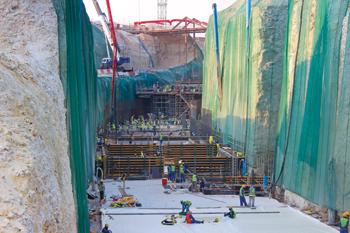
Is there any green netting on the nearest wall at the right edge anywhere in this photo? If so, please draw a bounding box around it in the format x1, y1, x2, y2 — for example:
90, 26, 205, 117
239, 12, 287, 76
274, 0, 350, 211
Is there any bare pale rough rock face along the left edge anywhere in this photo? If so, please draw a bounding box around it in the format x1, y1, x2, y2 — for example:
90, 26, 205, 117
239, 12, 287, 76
0, 0, 76, 232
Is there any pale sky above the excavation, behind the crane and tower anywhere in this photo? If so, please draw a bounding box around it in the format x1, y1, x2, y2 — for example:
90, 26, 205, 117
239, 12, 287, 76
83, 0, 236, 24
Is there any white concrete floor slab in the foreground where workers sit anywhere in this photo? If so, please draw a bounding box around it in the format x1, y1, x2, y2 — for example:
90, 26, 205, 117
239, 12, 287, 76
101, 179, 338, 233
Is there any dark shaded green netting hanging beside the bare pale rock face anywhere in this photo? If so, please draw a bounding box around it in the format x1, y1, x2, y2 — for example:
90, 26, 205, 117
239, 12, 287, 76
52, 0, 99, 232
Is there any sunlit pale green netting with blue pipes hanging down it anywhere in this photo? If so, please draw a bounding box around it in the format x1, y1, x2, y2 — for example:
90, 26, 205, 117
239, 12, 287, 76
202, 0, 288, 167
